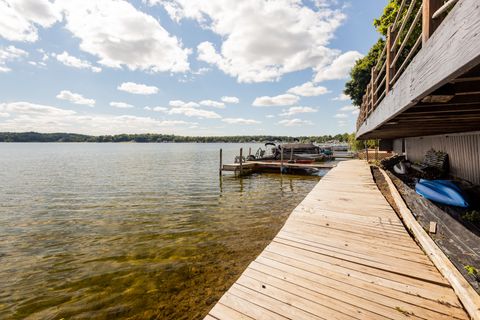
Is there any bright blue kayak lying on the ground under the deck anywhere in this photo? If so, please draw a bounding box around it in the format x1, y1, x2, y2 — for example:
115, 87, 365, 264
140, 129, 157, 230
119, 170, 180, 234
415, 179, 468, 208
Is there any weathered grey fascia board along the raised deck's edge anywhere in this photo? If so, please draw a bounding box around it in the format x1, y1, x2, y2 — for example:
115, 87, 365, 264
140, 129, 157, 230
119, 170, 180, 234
357, 0, 480, 138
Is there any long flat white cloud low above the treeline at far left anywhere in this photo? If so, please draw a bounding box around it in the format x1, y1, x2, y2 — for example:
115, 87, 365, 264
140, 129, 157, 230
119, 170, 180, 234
0, 102, 197, 135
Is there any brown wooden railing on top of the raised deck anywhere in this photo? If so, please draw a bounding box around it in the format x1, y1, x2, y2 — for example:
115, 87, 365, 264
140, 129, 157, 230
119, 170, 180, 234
357, 0, 459, 130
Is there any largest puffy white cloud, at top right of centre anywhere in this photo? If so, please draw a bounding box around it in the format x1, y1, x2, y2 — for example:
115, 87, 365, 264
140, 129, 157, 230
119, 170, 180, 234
147, 0, 345, 82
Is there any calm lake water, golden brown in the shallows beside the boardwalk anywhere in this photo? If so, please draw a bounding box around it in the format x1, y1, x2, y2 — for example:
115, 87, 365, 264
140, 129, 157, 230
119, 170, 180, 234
0, 144, 319, 319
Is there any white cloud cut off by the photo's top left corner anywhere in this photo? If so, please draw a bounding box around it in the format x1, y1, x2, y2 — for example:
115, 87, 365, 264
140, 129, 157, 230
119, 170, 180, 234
0, 0, 61, 42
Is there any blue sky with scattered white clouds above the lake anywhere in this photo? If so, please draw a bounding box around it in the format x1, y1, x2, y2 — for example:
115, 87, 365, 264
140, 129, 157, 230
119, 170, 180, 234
0, 0, 387, 136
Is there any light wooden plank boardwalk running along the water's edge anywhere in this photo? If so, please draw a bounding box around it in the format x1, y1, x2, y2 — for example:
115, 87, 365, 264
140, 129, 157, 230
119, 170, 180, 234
205, 160, 468, 320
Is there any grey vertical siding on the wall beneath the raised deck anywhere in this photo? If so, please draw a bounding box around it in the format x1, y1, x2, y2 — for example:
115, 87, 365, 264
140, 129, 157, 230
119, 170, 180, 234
406, 132, 480, 184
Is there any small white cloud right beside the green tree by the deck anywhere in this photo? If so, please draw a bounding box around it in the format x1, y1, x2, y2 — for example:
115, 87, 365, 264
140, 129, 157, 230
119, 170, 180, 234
314, 51, 363, 82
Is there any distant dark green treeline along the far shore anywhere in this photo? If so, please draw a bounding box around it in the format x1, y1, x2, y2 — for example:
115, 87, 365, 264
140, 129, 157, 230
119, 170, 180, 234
0, 132, 351, 143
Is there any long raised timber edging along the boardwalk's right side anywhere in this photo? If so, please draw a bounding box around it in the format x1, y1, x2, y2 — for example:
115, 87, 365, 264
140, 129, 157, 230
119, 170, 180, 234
379, 168, 480, 320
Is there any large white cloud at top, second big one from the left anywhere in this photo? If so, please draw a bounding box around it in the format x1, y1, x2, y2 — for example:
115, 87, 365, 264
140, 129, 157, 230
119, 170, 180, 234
57, 0, 191, 72
